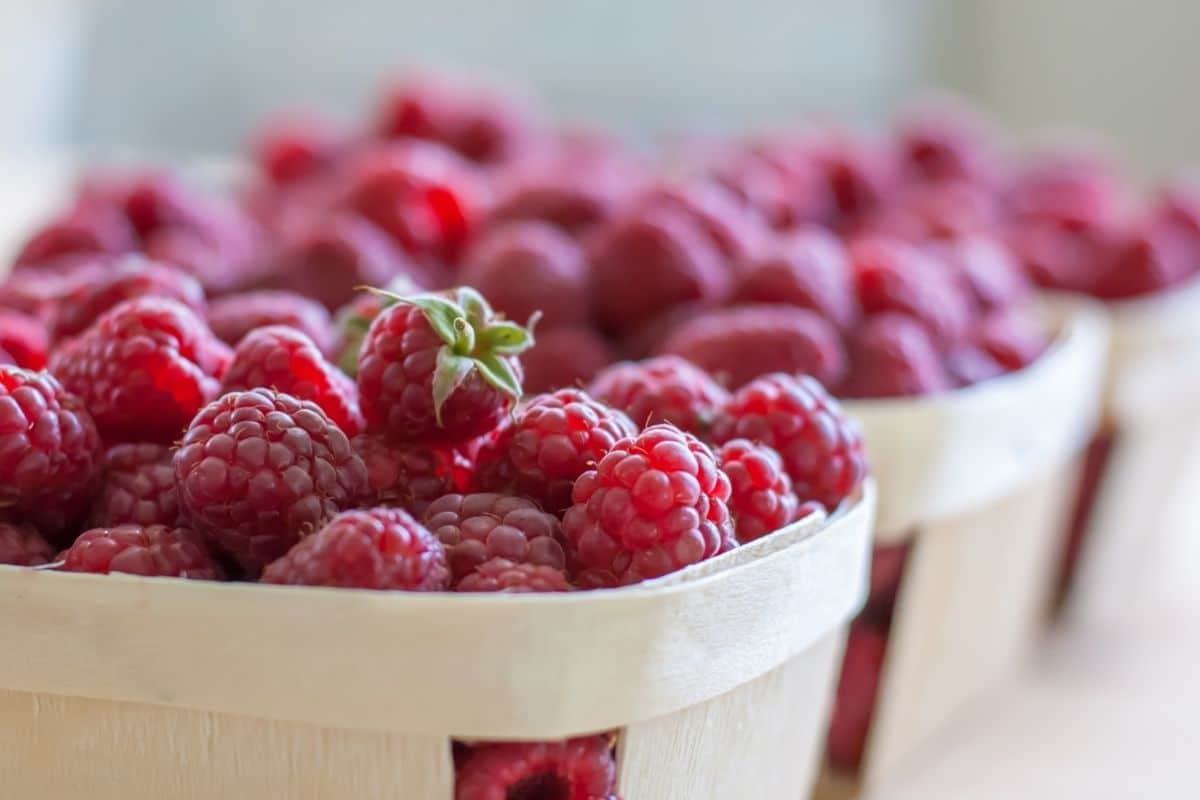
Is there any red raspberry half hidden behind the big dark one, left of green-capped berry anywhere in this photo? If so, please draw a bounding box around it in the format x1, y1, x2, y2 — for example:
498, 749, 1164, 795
221, 325, 365, 437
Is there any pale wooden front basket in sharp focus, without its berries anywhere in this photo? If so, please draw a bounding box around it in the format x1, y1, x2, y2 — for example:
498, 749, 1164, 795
0, 483, 875, 800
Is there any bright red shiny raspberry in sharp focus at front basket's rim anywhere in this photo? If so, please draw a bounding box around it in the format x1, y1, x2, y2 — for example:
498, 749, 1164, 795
563, 425, 736, 585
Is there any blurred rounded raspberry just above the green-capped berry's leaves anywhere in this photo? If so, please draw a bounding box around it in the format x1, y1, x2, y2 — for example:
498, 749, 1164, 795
458, 222, 590, 327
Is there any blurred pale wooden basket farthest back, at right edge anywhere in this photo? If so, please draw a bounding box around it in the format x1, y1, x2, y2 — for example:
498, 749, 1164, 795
1066, 281, 1200, 618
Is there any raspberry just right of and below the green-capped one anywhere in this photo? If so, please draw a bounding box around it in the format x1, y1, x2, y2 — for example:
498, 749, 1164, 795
476, 389, 637, 513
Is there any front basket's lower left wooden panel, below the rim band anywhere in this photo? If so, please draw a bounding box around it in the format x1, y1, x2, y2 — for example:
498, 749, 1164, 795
0, 691, 454, 800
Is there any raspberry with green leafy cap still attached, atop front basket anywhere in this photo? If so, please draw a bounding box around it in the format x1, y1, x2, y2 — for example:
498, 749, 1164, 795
358, 288, 532, 441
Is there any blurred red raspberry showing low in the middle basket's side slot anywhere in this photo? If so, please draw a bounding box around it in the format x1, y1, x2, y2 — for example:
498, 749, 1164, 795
828, 621, 888, 775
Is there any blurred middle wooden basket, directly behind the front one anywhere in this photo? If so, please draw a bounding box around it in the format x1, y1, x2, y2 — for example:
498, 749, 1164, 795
816, 297, 1108, 800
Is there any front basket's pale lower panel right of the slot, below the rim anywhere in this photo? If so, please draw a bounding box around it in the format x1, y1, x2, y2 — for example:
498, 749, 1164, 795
618, 627, 845, 800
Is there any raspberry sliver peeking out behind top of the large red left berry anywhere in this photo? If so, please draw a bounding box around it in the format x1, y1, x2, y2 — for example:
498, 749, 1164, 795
50, 255, 204, 342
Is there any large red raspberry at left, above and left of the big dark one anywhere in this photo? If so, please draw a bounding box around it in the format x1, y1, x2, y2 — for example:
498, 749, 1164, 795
50, 297, 229, 443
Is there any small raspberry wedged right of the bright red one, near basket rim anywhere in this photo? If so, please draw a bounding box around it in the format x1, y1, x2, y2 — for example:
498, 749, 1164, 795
716, 439, 800, 545
